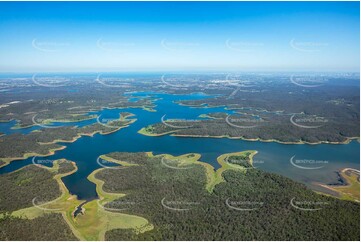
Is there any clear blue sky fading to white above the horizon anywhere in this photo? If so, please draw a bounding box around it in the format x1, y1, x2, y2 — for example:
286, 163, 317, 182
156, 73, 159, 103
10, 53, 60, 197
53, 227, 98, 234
0, 2, 360, 72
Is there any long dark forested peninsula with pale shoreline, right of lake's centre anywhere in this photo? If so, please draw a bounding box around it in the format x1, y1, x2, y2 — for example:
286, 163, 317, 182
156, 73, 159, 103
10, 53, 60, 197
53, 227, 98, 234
141, 109, 359, 143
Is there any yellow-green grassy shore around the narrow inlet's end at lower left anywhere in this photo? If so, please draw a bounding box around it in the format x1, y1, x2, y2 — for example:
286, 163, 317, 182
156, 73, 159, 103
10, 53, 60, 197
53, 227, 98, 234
11, 159, 153, 241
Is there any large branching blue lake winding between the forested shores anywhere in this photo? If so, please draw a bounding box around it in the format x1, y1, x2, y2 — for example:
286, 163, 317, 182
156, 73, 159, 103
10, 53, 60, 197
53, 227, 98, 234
0, 93, 360, 200
